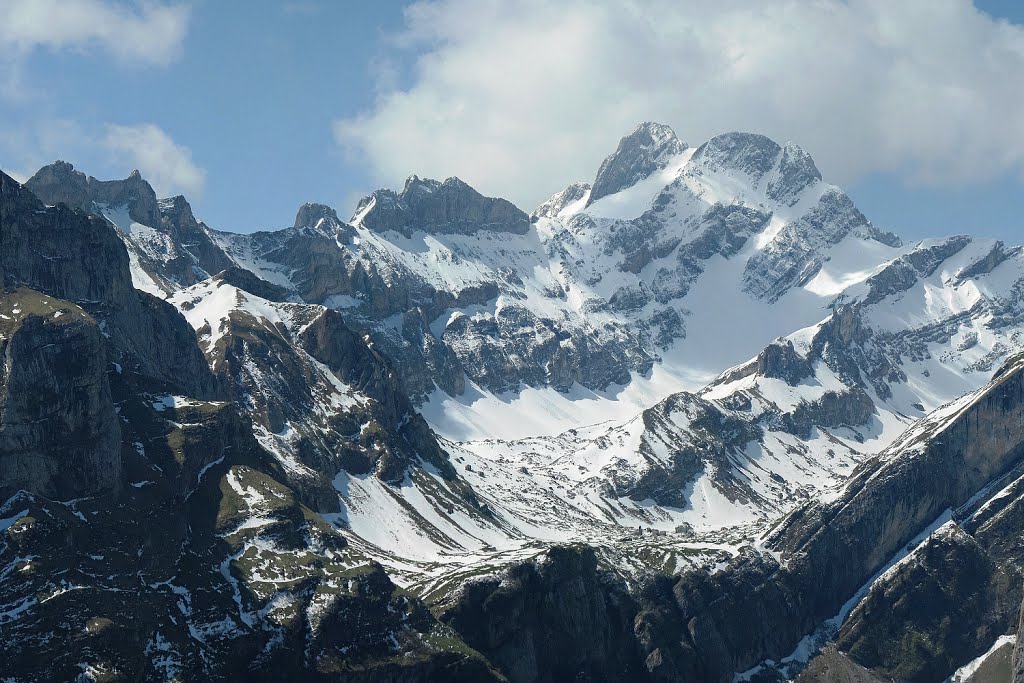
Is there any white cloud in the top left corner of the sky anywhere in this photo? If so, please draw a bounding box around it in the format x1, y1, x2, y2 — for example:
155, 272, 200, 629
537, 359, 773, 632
0, 0, 188, 65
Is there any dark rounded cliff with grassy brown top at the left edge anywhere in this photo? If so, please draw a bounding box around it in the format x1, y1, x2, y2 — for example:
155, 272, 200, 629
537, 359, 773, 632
0, 289, 121, 500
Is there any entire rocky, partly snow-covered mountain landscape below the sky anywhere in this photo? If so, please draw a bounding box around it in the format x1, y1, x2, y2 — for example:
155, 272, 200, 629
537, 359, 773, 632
0, 123, 1024, 683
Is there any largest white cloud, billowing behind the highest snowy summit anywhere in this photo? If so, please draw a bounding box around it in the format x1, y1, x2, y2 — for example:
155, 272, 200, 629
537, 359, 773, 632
334, 0, 1024, 208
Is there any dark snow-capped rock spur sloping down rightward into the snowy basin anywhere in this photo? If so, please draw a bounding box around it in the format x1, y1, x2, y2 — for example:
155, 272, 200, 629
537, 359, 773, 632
172, 271, 478, 524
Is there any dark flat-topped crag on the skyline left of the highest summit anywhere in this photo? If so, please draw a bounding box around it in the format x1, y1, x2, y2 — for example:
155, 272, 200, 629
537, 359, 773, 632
355, 175, 529, 237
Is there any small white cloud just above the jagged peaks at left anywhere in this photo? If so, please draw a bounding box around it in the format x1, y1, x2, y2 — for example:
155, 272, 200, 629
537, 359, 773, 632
98, 123, 206, 197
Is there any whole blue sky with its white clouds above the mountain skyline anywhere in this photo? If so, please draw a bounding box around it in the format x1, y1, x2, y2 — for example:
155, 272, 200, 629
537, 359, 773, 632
0, 0, 1024, 243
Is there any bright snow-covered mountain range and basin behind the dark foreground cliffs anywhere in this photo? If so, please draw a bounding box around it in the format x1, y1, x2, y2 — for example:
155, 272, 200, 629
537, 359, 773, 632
12, 123, 1024, 679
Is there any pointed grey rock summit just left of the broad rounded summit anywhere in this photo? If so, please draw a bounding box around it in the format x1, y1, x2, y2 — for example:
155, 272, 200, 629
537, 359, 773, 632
587, 121, 687, 206
